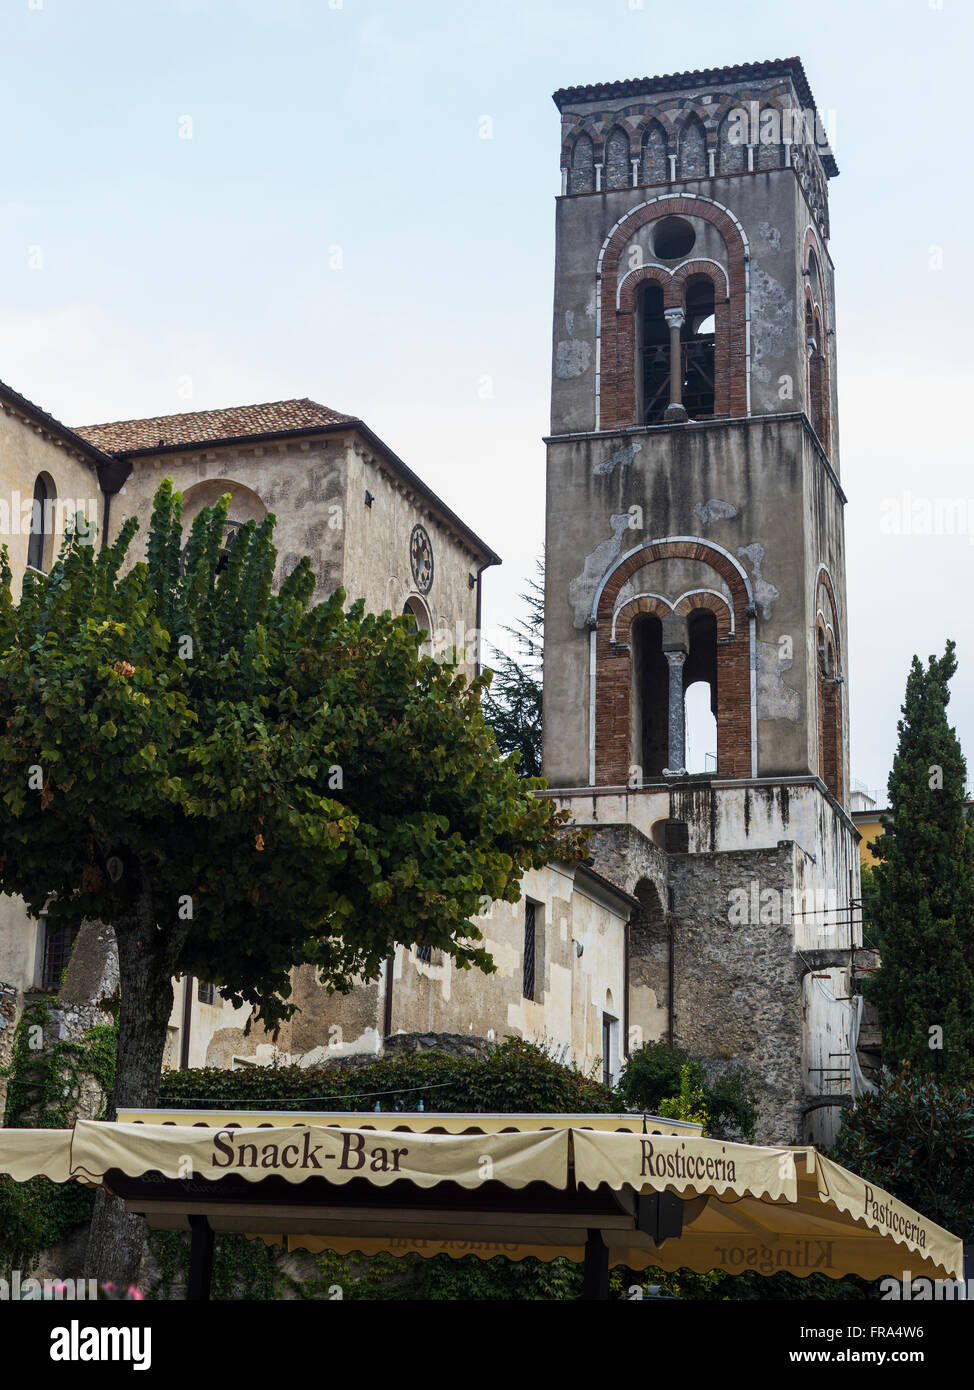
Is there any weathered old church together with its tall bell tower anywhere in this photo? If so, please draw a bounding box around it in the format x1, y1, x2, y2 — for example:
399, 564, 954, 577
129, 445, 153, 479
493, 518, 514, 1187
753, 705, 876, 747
0, 58, 868, 1143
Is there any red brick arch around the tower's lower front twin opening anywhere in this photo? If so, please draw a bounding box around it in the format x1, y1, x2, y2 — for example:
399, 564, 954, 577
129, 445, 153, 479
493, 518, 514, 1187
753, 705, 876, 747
589, 537, 754, 787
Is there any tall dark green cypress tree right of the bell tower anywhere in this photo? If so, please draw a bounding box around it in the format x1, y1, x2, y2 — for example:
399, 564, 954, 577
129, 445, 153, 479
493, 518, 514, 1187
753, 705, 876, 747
866, 642, 974, 1081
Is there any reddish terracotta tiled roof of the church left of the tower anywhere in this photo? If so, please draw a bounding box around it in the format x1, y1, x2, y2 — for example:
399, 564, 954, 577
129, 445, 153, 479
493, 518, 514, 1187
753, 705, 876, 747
75, 396, 356, 453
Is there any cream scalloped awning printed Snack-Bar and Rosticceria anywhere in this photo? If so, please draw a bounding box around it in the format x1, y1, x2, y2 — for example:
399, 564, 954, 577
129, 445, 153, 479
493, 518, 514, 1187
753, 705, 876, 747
0, 1112, 963, 1297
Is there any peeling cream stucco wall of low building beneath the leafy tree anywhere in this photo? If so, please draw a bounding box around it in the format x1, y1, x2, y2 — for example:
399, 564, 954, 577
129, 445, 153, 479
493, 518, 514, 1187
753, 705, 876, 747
171, 865, 632, 1074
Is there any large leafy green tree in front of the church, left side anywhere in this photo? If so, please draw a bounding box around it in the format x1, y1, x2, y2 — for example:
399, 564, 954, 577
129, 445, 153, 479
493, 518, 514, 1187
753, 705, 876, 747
0, 480, 575, 1282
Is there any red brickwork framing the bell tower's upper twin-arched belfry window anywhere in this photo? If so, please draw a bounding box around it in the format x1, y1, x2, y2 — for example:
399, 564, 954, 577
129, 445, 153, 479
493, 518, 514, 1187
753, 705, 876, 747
600, 195, 748, 430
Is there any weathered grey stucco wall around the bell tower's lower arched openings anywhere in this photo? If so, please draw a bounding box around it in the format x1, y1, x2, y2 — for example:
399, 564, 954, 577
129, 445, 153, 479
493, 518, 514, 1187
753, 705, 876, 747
545, 416, 848, 787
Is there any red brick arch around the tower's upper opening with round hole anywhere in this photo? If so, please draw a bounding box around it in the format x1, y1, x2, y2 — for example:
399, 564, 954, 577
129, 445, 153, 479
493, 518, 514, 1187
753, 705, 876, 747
596, 193, 749, 430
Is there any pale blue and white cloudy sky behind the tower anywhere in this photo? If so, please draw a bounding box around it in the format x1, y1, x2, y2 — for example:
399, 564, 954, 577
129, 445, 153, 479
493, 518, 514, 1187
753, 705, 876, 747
0, 0, 974, 791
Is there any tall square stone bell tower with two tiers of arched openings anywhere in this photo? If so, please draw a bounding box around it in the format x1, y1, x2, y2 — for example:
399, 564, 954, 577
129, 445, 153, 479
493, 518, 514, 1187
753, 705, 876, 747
545, 58, 859, 1140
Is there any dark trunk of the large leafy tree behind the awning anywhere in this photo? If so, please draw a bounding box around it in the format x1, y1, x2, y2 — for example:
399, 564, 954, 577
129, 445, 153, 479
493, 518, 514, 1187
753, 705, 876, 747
85, 892, 174, 1289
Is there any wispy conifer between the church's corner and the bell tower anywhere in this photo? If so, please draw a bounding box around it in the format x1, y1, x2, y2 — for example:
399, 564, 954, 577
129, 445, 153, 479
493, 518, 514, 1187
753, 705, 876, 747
484, 557, 545, 777
